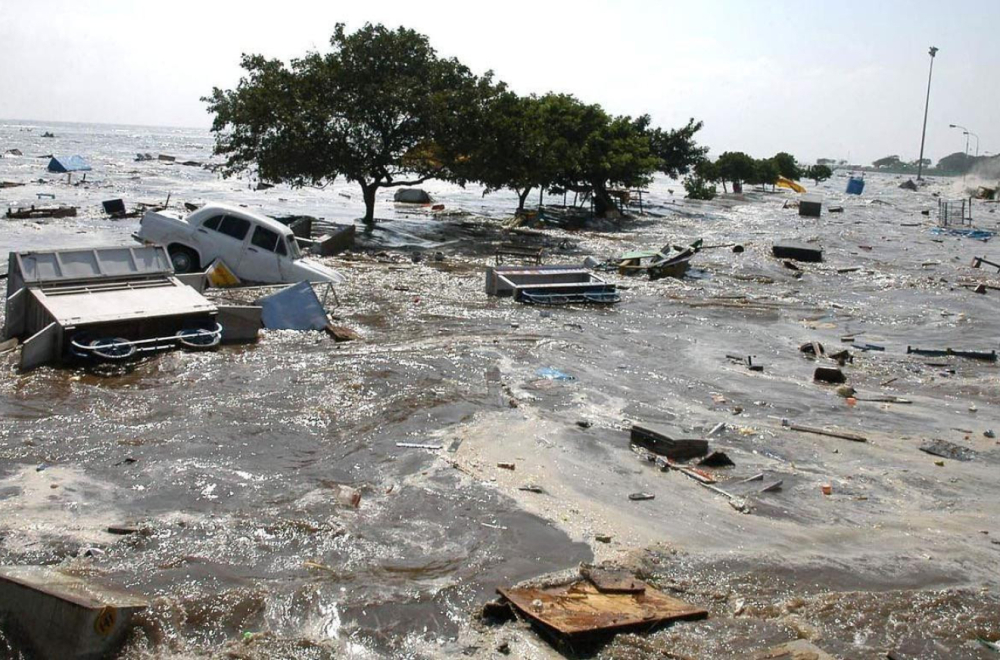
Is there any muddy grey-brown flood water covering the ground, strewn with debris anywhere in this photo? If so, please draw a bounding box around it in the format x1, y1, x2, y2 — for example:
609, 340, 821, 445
0, 123, 1000, 658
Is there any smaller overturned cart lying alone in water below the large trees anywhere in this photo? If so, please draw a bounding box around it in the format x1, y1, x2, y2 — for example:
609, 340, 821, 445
486, 266, 621, 305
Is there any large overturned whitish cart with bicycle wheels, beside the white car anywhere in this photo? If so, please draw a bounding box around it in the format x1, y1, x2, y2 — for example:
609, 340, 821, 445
3, 245, 259, 370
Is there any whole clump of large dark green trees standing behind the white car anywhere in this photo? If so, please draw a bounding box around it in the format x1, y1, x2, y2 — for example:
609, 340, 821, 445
203, 24, 707, 222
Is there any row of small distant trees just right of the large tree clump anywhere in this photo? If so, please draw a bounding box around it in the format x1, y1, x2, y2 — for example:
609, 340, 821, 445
684, 151, 833, 199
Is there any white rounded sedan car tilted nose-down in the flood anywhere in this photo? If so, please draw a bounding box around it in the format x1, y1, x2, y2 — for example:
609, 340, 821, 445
135, 204, 344, 284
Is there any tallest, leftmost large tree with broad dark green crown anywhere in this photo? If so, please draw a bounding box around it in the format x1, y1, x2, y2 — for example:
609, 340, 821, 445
204, 24, 501, 223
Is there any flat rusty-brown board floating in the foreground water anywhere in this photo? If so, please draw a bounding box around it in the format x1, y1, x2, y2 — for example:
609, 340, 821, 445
497, 580, 708, 636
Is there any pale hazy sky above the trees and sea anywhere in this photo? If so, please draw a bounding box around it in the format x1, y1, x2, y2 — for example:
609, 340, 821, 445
0, 0, 1000, 164
